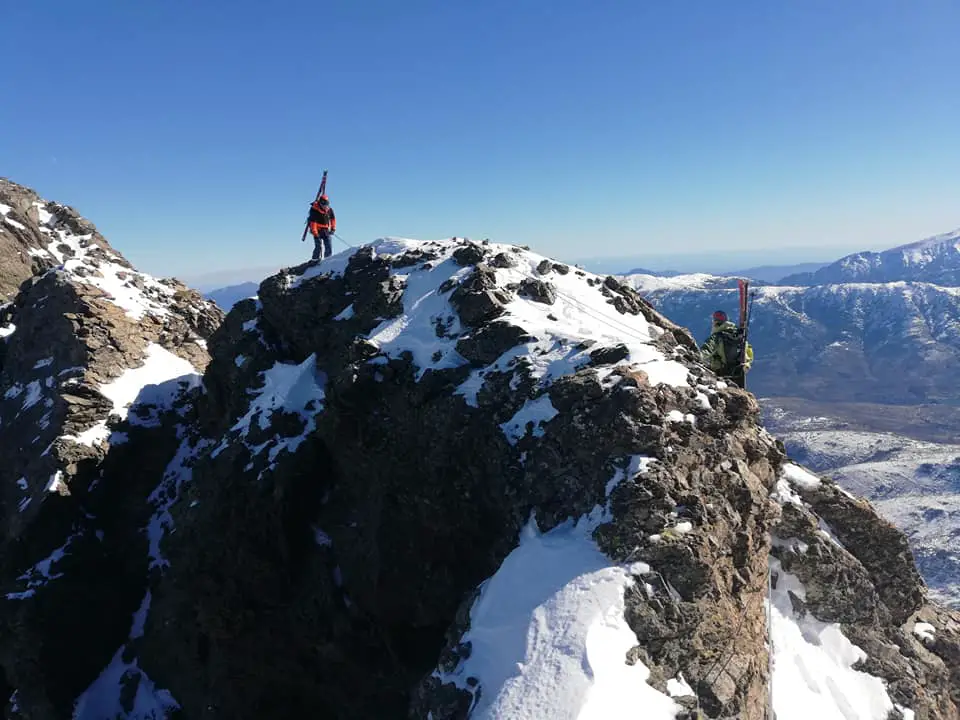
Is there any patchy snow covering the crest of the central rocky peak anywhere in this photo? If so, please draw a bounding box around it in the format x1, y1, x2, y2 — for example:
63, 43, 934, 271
287, 238, 688, 404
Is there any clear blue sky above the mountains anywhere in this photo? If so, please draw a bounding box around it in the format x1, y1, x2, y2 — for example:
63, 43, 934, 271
0, 0, 960, 276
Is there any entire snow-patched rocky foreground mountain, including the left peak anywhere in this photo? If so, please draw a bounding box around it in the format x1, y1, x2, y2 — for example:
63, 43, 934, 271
0, 184, 960, 720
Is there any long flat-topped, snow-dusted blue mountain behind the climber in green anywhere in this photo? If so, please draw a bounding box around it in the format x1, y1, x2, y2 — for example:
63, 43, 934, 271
623, 275, 960, 404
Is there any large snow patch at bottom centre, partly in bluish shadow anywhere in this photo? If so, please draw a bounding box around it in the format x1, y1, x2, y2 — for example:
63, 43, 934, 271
437, 515, 680, 720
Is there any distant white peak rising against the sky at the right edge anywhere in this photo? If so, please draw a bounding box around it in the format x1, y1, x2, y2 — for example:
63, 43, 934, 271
778, 230, 960, 287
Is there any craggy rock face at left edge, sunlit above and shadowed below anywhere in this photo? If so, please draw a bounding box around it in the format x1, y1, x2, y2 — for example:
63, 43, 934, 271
0, 180, 222, 718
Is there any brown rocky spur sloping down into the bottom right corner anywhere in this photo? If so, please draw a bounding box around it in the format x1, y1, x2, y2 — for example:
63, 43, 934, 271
773, 464, 960, 718
